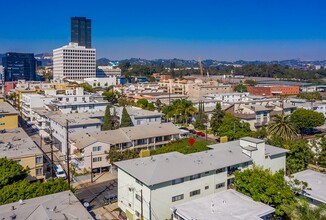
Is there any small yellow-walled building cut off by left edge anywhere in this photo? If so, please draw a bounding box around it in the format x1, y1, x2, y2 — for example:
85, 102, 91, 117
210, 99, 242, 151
0, 102, 18, 130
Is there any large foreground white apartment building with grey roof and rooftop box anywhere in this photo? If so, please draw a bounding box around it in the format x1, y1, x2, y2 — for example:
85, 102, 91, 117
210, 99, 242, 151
115, 137, 287, 219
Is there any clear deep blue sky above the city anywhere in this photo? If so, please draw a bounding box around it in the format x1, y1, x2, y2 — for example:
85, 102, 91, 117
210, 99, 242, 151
0, 0, 326, 61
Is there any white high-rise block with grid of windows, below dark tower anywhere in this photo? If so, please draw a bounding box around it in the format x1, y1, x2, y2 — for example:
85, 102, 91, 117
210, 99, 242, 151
53, 43, 96, 81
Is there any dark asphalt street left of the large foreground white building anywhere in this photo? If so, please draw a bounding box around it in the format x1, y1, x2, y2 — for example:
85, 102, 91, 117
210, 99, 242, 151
75, 180, 118, 210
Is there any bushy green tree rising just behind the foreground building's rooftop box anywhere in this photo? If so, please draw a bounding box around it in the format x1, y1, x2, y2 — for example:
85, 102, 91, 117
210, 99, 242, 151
218, 112, 251, 140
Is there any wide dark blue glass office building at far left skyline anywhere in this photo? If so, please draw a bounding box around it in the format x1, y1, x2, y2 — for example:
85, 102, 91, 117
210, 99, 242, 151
2, 52, 36, 82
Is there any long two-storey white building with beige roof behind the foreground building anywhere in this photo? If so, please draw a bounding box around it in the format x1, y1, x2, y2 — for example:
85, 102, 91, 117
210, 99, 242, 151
69, 123, 180, 170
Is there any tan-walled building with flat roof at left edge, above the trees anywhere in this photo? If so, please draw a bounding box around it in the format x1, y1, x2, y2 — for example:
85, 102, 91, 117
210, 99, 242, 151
0, 128, 46, 180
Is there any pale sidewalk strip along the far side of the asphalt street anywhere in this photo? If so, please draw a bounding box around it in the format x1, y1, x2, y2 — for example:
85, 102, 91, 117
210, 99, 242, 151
72, 172, 118, 189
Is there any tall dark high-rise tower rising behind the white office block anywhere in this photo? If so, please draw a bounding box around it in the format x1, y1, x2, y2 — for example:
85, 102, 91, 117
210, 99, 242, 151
71, 17, 92, 48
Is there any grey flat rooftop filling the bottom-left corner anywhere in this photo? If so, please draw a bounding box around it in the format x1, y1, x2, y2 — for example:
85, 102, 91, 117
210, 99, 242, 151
0, 191, 94, 220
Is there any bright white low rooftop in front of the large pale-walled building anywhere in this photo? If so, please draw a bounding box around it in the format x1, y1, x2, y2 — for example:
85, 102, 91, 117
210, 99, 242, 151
171, 189, 275, 220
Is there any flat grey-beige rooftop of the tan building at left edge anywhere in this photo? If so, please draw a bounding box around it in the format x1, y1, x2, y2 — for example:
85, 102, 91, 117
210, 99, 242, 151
0, 128, 43, 159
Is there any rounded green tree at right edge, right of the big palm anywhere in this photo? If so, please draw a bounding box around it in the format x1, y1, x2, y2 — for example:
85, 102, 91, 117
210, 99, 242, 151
291, 109, 325, 136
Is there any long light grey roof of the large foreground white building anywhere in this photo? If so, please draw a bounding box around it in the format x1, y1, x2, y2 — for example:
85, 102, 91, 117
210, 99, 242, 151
115, 138, 288, 186
